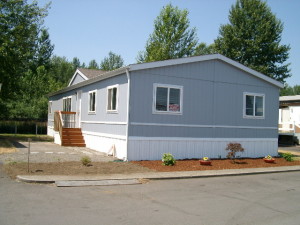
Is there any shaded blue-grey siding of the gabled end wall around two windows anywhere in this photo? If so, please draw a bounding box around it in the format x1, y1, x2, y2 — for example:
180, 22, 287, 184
129, 60, 279, 138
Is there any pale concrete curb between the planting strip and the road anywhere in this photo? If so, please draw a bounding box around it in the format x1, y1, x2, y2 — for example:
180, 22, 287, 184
17, 166, 300, 184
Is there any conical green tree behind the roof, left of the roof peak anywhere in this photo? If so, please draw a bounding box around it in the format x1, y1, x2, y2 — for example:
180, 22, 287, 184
137, 4, 198, 63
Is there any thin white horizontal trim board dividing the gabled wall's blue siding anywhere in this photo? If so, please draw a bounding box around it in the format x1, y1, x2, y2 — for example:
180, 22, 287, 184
130, 122, 278, 130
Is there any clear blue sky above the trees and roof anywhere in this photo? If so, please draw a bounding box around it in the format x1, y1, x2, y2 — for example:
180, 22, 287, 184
34, 0, 300, 85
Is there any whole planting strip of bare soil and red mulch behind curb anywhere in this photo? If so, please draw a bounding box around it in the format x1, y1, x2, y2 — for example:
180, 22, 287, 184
3, 158, 300, 178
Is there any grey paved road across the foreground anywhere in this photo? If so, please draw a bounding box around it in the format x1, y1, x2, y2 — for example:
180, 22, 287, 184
0, 166, 300, 225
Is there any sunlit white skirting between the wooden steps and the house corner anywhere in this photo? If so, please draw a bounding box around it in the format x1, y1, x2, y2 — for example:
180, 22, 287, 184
82, 131, 127, 160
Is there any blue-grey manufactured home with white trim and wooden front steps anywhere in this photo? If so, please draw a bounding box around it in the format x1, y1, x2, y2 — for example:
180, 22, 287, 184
48, 54, 283, 160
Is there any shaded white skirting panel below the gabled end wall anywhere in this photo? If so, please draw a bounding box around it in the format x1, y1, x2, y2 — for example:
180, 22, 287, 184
127, 137, 278, 160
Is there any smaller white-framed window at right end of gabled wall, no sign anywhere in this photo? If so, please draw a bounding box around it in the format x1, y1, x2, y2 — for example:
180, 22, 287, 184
244, 93, 265, 119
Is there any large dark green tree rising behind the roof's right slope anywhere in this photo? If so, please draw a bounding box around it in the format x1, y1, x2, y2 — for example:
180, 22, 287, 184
215, 0, 291, 82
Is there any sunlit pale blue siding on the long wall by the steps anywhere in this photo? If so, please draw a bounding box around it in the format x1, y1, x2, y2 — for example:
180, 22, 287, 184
48, 74, 128, 135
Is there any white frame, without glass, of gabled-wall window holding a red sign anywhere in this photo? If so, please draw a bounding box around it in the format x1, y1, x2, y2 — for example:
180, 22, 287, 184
152, 83, 183, 115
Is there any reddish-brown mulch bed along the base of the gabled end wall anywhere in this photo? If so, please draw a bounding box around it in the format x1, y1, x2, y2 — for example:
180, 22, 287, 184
132, 158, 300, 172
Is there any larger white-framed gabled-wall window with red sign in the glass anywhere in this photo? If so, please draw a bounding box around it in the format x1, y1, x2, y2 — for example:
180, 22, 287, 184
153, 84, 183, 114
